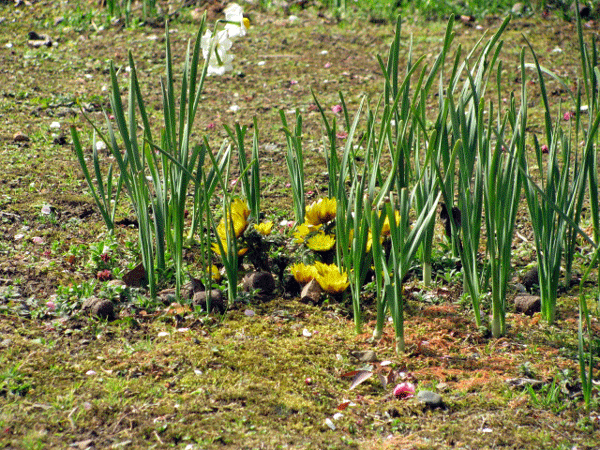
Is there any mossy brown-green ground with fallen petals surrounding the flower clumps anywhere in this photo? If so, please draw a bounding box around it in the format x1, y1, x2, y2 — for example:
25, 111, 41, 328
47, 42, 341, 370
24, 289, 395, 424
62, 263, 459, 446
0, 2, 600, 449
